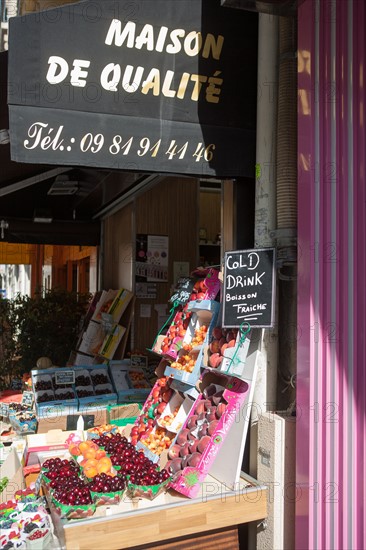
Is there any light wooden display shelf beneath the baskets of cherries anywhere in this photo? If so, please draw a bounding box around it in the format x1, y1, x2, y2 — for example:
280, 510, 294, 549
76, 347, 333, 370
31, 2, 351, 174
53, 474, 267, 550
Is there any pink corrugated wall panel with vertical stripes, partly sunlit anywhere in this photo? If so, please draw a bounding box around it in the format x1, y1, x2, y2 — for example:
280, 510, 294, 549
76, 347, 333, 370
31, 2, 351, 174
296, 0, 366, 550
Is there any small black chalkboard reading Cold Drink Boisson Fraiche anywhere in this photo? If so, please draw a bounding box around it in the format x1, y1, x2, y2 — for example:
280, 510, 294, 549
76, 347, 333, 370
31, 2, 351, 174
222, 248, 275, 327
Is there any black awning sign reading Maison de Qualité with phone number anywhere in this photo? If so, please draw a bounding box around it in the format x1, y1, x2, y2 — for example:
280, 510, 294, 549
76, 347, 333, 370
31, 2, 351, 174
8, 0, 257, 177
